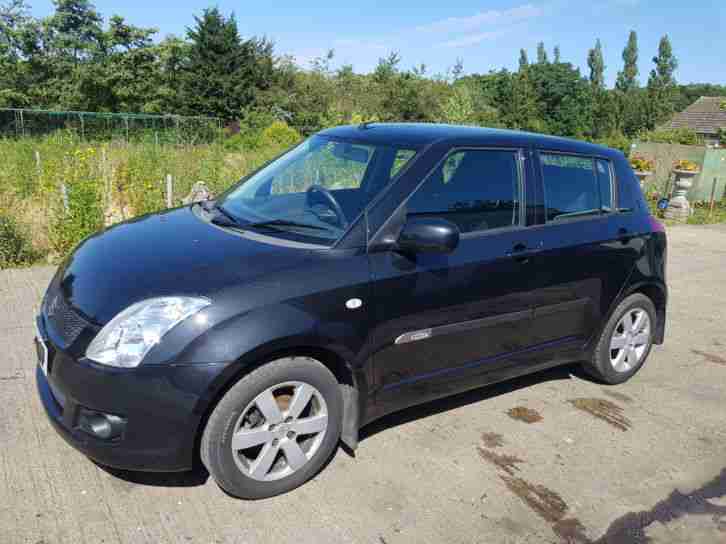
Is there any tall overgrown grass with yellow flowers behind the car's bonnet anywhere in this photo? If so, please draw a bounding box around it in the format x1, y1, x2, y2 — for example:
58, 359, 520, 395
0, 124, 299, 268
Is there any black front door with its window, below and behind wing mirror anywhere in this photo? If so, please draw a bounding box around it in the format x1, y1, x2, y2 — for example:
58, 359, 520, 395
370, 149, 536, 412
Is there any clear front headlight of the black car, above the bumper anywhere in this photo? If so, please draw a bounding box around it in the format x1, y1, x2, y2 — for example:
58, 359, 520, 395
86, 297, 211, 368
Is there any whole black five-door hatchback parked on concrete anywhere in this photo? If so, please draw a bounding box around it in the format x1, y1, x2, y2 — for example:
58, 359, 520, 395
36, 124, 667, 498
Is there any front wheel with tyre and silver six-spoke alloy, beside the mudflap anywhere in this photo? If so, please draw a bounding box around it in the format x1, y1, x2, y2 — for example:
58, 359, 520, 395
200, 357, 343, 499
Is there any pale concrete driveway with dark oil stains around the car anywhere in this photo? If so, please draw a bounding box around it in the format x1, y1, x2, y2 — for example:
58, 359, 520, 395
0, 223, 726, 544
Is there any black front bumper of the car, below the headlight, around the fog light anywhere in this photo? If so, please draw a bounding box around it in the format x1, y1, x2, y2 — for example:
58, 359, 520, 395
36, 324, 233, 471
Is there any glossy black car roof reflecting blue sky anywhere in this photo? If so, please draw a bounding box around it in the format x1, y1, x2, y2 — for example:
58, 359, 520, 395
318, 123, 620, 157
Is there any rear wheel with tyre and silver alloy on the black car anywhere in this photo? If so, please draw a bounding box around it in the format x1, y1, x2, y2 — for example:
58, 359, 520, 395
584, 293, 656, 385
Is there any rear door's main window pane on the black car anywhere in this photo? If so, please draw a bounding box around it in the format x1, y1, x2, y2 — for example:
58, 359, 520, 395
540, 153, 602, 222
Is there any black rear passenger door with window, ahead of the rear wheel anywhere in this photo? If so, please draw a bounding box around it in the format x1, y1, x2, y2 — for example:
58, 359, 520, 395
532, 151, 635, 362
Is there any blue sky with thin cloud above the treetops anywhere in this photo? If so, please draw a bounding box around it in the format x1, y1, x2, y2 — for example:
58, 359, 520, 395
29, 0, 726, 84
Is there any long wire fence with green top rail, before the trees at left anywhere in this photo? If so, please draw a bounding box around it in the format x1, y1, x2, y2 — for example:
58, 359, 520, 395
0, 108, 223, 144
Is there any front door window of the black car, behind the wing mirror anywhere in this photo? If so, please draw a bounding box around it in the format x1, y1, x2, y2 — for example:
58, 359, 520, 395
407, 150, 521, 234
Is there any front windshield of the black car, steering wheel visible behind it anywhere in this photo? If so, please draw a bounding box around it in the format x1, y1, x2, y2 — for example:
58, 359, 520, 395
217, 136, 416, 245
